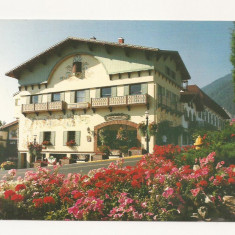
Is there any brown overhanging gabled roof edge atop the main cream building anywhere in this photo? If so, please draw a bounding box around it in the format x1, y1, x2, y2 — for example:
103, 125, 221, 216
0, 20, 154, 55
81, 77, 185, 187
6, 37, 190, 80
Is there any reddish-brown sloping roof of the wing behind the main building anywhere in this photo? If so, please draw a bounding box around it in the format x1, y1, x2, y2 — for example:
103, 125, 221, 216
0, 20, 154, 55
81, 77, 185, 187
181, 85, 230, 119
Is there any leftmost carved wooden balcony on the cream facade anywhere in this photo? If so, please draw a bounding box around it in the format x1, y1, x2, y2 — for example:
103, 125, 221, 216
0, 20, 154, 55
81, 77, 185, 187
22, 101, 66, 115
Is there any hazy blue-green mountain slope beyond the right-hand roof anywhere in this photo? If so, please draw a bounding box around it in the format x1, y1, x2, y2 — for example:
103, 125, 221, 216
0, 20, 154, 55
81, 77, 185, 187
202, 74, 235, 116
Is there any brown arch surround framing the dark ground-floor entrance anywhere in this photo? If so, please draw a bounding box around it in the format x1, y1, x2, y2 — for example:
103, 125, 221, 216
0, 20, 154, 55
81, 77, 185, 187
94, 120, 141, 152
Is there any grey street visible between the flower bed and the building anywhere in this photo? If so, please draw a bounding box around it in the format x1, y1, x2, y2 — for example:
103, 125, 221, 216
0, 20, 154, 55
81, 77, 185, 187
0, 157, 141, 179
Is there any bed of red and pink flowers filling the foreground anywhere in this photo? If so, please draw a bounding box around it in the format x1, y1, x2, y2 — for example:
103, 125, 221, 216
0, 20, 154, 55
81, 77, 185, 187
0, 146, 235, 221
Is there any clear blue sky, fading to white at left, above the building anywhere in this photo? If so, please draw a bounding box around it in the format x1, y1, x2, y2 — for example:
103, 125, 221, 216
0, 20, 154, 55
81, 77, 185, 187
0, 20, 233, 123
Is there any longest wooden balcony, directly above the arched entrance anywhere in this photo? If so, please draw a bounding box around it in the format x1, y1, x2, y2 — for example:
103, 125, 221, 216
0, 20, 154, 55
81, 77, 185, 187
91, 94, 148, 112
